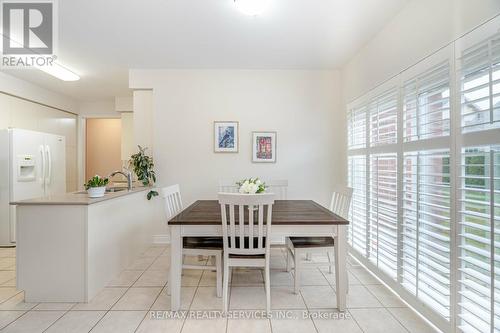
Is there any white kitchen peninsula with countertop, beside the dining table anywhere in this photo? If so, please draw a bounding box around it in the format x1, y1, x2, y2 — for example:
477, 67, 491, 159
16, 187, 165, 303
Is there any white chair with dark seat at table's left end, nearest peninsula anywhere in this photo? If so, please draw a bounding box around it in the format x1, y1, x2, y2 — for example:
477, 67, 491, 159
161, 184, 223, 297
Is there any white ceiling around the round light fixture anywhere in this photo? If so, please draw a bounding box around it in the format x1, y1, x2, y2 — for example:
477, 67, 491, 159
1, 0, 409, 101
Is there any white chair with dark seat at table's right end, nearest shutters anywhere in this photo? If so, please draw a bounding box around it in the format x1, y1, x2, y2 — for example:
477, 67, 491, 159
285, 187, 352, 294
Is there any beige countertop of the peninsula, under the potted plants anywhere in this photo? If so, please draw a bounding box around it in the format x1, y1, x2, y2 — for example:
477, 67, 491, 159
10, 186, 152, 206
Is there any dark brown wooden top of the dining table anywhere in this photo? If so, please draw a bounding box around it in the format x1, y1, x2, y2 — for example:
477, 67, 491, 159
168, 200, 349, 225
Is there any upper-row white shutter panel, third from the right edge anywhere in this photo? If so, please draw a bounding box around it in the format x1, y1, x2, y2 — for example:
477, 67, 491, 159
369, 89, 398, 146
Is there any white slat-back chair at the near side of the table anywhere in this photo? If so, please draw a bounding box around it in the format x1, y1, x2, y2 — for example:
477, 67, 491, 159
218, 193, 274, 313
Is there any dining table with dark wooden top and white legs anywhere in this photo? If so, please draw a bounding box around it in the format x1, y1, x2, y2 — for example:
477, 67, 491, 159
168, 200, 349, 311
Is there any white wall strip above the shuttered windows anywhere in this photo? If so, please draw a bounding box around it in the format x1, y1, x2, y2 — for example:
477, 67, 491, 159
341, 0, 500, 105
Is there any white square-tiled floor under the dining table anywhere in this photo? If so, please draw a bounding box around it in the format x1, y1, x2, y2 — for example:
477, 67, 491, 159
0, 246, 434, 333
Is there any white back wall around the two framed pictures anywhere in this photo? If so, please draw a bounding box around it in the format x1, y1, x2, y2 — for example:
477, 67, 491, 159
130, 70, 345, 205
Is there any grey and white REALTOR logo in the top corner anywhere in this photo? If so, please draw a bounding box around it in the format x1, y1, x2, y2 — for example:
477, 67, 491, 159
0, 0, 57, 68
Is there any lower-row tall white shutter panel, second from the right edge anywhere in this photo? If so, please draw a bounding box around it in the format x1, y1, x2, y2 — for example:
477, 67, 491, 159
401, 150, 451, 318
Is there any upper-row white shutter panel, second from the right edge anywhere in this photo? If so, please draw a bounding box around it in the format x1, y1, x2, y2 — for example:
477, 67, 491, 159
403, 61, 450, 141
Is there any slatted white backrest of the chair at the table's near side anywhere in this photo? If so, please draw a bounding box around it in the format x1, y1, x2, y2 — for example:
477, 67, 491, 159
219, 193, 274, 255
